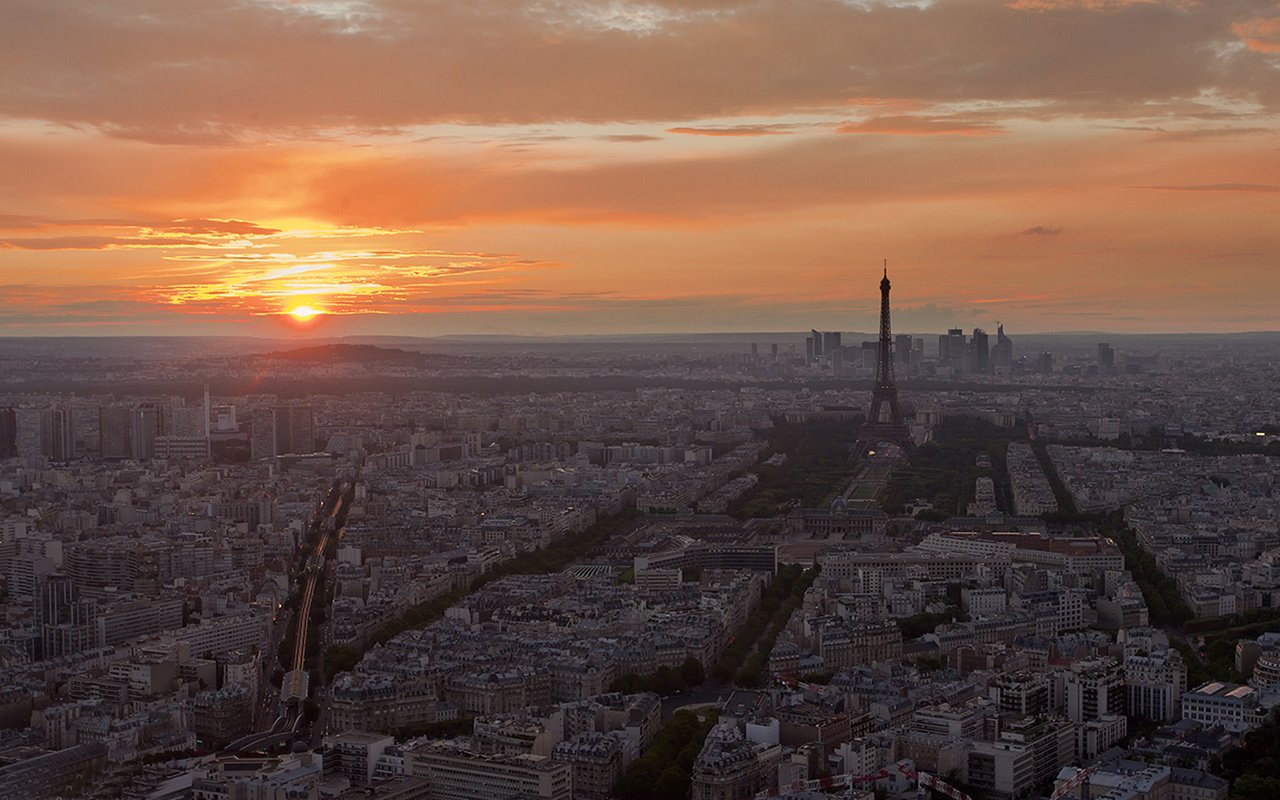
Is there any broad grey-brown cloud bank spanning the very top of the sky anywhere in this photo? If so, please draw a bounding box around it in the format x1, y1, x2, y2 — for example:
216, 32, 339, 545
0, 0, 1280, 140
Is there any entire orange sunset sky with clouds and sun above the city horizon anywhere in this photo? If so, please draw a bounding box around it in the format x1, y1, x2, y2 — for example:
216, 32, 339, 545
0, 0, 1280, 337
